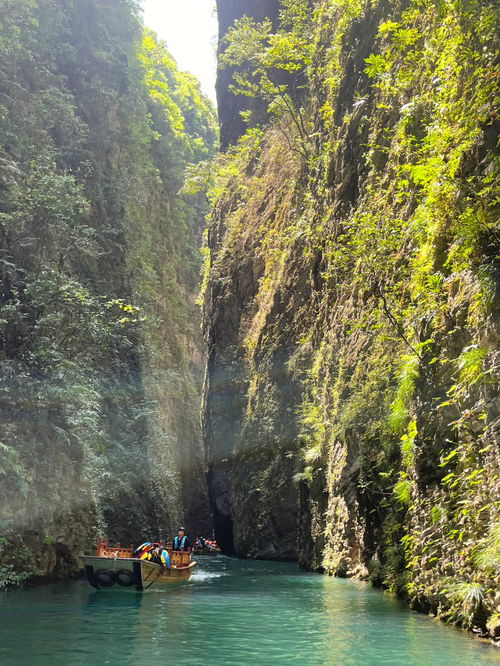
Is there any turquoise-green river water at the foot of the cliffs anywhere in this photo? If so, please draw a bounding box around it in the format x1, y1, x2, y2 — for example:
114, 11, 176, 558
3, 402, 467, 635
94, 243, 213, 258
0, 556, 500, 666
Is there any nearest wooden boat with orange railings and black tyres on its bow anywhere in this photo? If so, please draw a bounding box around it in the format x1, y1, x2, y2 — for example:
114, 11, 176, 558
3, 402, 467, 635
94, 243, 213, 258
82, 539, 196, 592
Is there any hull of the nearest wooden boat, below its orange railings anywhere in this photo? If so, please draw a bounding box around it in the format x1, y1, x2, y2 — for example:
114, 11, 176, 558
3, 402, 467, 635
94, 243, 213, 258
82, 555, 196, 592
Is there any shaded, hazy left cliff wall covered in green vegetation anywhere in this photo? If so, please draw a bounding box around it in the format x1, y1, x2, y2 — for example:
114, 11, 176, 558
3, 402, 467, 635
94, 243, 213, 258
0, 0, 216, 582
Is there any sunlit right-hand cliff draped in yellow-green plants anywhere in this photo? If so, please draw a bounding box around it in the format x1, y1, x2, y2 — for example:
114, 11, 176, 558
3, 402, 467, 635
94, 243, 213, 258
204, 0, 500, 634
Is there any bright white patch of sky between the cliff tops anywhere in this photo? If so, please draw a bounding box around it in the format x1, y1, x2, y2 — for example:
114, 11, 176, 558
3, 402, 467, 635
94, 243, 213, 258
142, 0, 217, 100
